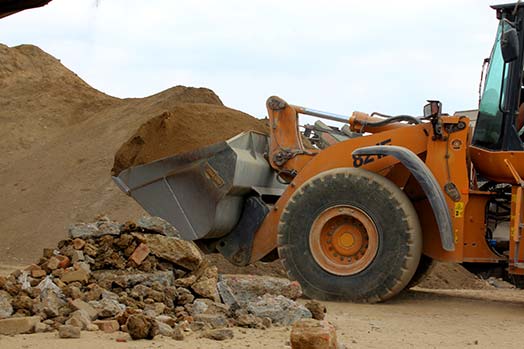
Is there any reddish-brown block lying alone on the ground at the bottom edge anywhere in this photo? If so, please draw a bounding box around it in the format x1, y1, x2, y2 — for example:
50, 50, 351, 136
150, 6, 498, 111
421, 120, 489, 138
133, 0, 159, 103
290, 319, 338, 349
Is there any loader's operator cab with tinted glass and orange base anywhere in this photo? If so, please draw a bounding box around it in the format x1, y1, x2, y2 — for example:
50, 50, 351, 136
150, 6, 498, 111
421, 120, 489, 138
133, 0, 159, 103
470, 3, 524, 184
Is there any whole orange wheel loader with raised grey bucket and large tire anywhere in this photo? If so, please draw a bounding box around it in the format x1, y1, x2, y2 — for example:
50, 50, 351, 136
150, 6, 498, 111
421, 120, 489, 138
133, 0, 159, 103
113, 3, 524, 302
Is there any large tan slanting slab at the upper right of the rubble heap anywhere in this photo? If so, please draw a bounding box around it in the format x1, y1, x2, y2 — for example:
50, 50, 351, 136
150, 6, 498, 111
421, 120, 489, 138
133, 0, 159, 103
133, 233, 202, 270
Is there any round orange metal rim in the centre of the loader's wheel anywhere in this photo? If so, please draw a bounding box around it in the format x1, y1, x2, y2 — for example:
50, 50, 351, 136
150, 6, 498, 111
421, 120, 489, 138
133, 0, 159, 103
309, 205, 378, 276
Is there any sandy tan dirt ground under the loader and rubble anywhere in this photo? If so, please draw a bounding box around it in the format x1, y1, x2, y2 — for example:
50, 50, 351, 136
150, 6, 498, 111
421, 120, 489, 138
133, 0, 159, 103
0, 278, 524, 349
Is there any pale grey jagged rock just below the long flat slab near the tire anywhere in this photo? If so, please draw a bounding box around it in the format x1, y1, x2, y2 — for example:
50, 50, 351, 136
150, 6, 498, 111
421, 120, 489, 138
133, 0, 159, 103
246, 294, 312, 326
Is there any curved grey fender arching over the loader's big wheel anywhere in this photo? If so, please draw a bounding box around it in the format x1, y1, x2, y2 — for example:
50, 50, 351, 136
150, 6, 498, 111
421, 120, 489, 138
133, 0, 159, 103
353, 145, 455, 252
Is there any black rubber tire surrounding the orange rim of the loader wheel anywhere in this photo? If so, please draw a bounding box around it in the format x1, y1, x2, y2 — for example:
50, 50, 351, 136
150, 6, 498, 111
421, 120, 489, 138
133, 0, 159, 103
278, 168, 422, 303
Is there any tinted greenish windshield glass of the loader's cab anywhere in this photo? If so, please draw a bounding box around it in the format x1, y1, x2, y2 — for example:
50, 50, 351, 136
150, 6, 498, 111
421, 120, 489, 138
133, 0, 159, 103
473, 21, 509, 149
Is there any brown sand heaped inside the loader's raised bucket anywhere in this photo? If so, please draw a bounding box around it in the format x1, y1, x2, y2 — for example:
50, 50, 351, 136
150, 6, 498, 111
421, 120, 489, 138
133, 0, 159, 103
112, 103, 268, 175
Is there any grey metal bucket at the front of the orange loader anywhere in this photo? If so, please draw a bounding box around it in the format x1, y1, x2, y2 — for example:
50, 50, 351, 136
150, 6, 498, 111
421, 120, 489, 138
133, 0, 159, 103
113, 131, 285, 240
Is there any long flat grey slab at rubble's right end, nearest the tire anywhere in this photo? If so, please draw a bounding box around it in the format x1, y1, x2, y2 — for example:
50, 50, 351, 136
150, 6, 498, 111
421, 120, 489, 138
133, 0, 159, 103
219, 274, 302, 306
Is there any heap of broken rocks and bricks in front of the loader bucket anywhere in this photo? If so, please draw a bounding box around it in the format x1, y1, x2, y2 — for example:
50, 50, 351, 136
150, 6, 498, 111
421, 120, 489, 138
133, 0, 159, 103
0, 217, 313, 340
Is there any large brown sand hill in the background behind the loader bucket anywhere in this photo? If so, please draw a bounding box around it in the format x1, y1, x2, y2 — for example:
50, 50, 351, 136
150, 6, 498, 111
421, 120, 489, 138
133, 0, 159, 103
0, 45, 252, 264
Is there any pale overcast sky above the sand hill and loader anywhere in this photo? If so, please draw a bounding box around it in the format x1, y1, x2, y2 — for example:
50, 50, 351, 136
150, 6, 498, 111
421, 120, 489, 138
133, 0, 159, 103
0, 0, 504, 121
